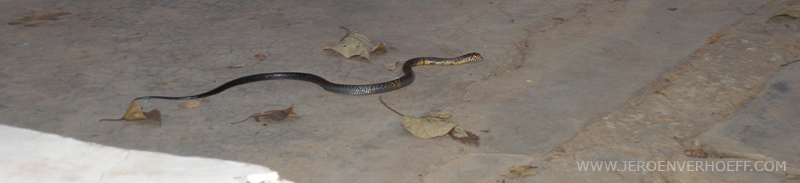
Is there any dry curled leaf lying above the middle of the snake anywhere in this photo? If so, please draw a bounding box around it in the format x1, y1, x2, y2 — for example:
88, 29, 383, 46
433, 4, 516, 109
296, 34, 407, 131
324, 27, 386, 60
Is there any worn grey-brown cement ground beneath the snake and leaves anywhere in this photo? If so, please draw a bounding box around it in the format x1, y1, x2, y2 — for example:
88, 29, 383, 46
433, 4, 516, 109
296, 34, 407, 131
0, 0, 800, 182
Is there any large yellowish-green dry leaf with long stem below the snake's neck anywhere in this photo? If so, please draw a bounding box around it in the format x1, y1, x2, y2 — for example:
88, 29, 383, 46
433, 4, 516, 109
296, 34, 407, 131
378, 97, 479, 140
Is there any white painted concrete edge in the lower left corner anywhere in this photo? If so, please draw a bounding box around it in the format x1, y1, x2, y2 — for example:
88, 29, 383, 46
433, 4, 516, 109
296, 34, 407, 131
0, 125, 291, 183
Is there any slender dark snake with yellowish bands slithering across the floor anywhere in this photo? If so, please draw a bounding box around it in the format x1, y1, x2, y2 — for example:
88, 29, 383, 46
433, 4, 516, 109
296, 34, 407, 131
134, 53, 483, 100
